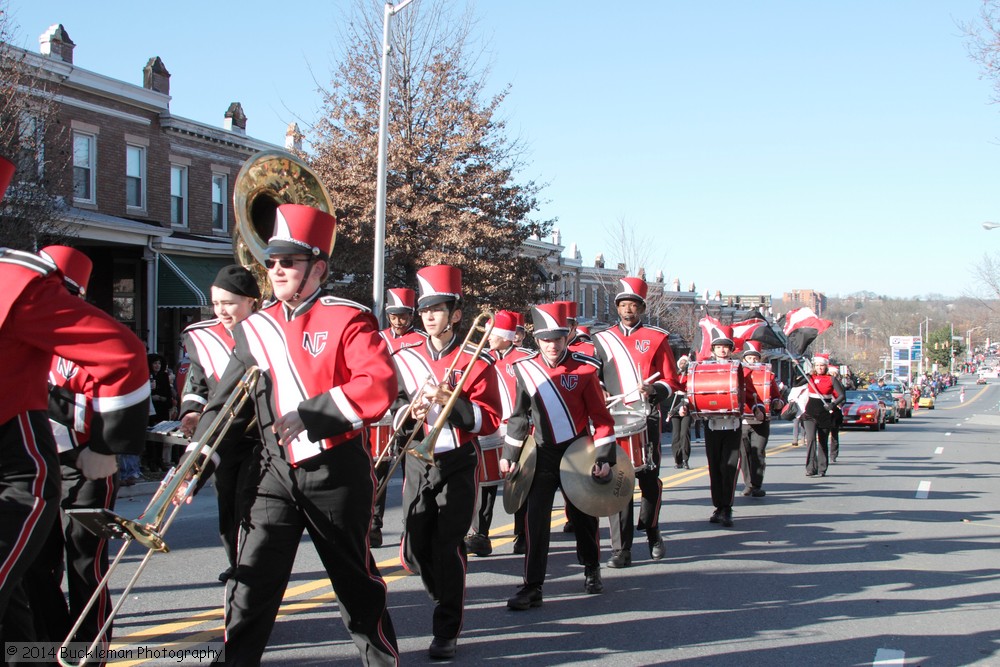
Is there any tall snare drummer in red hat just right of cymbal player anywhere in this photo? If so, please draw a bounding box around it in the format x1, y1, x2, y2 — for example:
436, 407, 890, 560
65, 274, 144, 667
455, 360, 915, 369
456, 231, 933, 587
594, 278, 682, 568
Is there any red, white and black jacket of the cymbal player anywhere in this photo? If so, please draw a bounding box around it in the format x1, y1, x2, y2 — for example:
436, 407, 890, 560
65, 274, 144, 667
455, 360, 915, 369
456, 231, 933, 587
503, 350, 616, 464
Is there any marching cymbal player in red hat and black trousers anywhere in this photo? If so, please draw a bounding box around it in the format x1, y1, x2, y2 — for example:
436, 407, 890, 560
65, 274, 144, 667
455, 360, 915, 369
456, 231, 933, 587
500, 303, 617, 611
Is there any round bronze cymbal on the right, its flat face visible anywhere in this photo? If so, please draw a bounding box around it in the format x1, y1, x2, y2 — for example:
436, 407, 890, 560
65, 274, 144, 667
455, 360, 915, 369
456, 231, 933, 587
559, 435, 635, 517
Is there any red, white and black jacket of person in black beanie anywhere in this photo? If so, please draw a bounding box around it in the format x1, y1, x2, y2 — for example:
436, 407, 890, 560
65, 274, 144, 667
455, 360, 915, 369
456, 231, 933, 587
180, 318, 236, 417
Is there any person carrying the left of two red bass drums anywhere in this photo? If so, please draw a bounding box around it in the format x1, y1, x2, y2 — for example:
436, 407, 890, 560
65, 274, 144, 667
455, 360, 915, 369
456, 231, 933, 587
701, 327, 764, 528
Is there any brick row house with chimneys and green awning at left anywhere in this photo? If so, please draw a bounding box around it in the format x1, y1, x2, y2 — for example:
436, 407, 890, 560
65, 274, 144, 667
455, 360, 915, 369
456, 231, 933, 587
11, 25, 282, 364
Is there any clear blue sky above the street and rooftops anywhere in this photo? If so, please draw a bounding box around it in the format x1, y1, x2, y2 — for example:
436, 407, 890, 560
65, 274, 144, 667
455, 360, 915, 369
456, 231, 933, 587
9, 0, 1000, 297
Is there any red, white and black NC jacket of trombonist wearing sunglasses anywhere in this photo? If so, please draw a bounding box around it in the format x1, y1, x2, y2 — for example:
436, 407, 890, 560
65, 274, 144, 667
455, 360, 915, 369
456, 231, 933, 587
189, 290, 396, 466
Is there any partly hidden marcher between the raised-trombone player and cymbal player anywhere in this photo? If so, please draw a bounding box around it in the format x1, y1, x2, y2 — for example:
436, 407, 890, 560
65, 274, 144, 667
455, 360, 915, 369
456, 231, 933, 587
465, 310, 532, 556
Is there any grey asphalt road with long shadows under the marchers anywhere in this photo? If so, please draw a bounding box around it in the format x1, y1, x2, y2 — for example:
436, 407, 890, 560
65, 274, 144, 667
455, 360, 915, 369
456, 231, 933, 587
103, 376, 1000, 667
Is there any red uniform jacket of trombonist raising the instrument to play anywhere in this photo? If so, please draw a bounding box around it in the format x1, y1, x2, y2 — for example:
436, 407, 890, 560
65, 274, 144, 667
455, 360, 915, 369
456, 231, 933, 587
392, 335, 501, 454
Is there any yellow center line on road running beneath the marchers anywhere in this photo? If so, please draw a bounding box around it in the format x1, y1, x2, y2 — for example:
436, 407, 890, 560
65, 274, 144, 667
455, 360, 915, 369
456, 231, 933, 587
111, 442, 798, 667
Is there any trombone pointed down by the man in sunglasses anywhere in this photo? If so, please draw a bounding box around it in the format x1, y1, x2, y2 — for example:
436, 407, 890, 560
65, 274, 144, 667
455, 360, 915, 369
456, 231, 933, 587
59, 366, 260, 667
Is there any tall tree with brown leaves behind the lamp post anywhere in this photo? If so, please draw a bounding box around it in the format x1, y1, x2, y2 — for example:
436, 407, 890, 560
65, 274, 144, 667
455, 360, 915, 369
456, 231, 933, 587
310, 0, 552, 318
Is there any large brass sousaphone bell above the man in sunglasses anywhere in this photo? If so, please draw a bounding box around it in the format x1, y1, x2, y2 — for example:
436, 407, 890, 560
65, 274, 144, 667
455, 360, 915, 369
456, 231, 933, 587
233, 150, 337, 299
